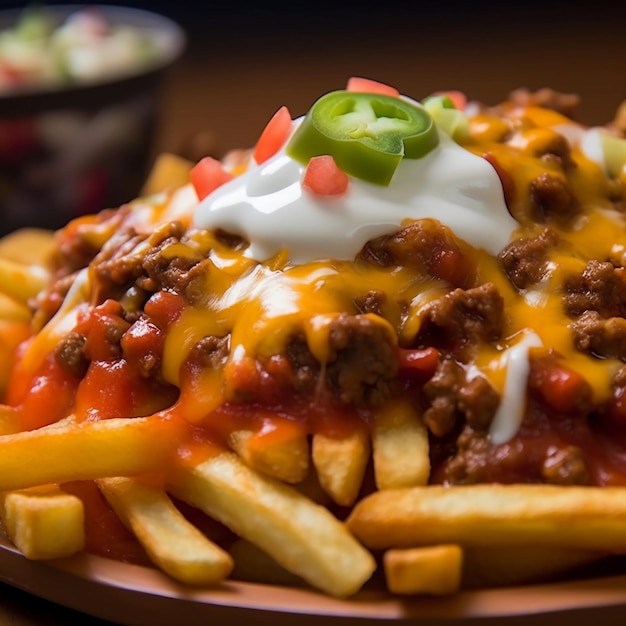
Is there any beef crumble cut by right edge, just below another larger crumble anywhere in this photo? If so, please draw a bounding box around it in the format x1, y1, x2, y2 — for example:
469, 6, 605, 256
570, 311, 626, 361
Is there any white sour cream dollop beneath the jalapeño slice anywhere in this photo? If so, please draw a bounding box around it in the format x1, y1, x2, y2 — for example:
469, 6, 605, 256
194, 118, 518, 263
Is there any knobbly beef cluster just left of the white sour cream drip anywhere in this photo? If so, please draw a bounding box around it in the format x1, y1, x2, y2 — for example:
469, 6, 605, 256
423, 359, 500, 437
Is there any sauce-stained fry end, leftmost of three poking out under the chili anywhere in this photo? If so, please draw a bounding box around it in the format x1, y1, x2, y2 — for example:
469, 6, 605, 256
228, 430, 309, 483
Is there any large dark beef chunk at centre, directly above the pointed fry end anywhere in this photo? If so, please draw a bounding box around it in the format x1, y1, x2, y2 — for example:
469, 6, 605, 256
325, 314, 398, 406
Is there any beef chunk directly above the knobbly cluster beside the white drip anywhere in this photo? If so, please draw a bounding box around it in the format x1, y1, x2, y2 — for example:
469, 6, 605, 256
423, 283, 504, 352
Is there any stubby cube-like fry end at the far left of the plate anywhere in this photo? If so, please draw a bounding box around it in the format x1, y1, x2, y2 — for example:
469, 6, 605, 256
2, 485, 85, 560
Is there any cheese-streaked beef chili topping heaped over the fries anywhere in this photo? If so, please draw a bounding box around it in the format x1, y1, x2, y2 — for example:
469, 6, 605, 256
13, 91, 626, 485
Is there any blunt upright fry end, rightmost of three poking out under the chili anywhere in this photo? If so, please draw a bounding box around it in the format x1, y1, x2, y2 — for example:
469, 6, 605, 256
372, 399, 430, 489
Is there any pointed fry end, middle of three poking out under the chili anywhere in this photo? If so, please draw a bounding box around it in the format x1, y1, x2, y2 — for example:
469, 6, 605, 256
311, 431, 370, 506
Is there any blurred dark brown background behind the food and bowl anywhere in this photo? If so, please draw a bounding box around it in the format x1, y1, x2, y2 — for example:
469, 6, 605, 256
0, 0, 626, 227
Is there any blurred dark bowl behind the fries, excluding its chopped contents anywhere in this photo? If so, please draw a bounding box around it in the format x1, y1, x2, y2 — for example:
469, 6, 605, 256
0, 5, 186, 235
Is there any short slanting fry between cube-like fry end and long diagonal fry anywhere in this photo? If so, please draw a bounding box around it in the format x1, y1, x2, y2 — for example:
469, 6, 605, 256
96, 477, 233, 585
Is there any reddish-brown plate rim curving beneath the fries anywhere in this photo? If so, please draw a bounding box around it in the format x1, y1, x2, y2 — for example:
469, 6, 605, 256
0, 537, 626, 626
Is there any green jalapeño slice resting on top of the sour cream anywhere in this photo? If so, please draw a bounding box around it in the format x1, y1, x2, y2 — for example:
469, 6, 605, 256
286, 91, 439, 185
